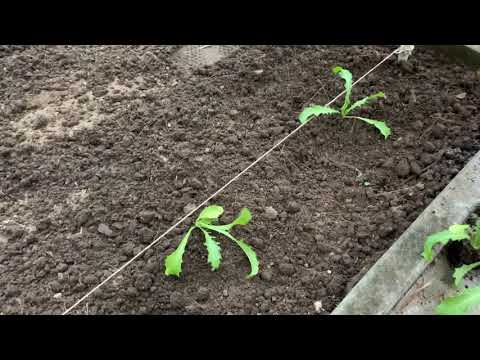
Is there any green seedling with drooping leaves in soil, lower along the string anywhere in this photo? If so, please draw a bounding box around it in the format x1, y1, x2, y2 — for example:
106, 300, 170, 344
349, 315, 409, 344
165, 205, 258, 278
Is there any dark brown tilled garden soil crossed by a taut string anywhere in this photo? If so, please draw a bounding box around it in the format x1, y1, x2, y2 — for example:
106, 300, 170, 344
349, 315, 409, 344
0, 46, 480, 314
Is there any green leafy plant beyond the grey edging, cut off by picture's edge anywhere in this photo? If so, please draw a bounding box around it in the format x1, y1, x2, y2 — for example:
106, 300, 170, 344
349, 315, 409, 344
422, 220, 480, 315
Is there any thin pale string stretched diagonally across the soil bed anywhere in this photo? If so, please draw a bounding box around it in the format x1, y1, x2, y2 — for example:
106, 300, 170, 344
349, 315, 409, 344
62, 46, 405, 315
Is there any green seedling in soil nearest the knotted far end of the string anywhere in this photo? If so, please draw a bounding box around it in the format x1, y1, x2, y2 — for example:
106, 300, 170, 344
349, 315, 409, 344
298, 66, 392, 139
